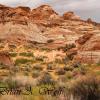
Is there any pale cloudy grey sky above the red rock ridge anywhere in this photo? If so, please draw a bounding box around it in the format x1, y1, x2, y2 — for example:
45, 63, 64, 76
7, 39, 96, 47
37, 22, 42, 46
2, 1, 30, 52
0, 0, 100, 22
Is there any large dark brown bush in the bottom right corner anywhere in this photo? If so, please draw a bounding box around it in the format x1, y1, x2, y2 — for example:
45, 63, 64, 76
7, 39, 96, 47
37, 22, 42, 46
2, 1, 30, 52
71, 76, 100, 100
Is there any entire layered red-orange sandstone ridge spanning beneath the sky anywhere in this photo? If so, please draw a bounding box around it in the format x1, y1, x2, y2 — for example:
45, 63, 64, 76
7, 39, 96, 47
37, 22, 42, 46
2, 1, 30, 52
0, 5, 100, 63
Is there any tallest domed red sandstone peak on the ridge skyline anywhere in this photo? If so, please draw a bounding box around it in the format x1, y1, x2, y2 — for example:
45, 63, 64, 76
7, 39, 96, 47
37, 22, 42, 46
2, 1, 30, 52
31, 5, 59, 20
